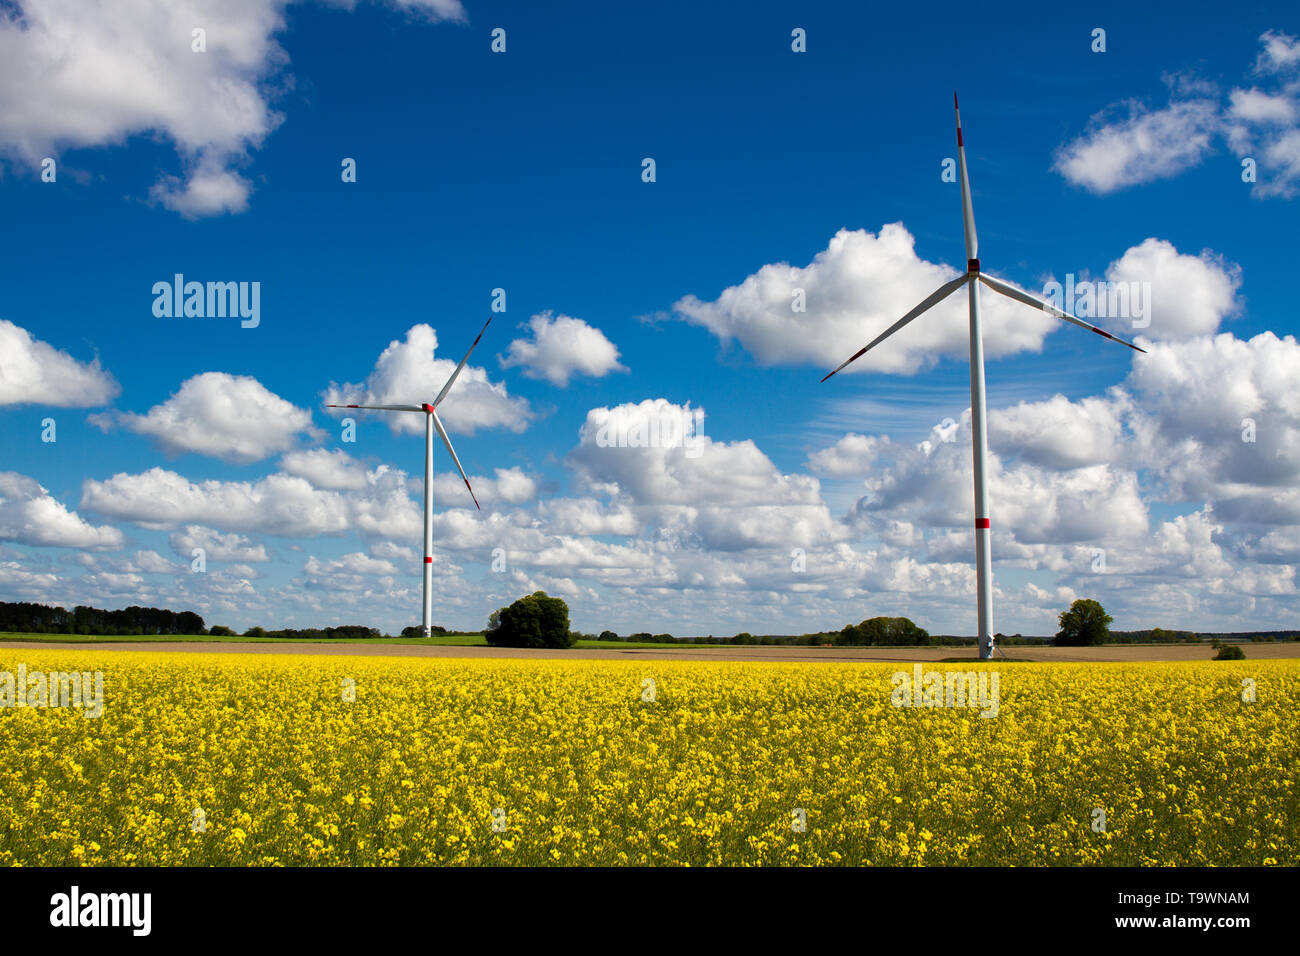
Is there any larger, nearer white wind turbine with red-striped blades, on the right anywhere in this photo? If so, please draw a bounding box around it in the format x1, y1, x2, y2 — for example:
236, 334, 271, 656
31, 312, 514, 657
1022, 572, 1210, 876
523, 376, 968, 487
822, 92, 1145, 661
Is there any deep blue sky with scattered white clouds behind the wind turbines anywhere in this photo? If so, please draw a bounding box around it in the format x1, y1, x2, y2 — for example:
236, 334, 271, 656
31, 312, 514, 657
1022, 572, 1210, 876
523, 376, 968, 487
0, 0, 1300, 635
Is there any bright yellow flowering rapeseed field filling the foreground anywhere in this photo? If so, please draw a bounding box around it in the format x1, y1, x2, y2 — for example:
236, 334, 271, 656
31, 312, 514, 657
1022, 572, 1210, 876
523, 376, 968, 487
0, 644, 1300, 866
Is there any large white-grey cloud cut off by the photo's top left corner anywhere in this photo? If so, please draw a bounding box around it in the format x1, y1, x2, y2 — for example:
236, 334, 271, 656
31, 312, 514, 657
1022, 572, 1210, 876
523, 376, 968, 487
0, 0, 465, 217
